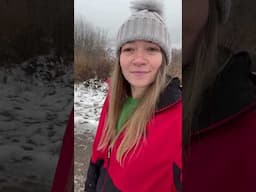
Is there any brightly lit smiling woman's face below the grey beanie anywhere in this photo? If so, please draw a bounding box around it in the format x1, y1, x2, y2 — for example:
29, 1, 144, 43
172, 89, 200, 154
120, 41, 162, 98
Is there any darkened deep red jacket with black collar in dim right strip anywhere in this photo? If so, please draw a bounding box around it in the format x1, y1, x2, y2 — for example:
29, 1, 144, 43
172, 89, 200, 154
183, 52, 256, 192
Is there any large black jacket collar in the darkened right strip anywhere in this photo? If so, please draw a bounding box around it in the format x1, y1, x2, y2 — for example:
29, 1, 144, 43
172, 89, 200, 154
193, 52, 255, 134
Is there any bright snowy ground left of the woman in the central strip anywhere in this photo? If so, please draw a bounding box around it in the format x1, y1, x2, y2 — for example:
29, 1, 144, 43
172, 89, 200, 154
74, 80, 107, 192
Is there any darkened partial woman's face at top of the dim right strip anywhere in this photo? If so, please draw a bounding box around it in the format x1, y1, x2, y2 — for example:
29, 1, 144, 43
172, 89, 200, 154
182, 0, 209, 65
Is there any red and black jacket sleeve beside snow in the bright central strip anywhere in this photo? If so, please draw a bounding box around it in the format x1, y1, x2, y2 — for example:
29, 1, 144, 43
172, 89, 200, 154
84, 96, 108, 192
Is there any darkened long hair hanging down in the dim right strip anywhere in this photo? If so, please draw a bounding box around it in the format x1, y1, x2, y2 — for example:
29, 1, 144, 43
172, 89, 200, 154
182, 0, 219, 152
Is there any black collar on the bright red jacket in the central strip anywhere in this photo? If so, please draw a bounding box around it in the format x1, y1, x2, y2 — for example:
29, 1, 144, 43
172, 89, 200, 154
156, 78, 181, 112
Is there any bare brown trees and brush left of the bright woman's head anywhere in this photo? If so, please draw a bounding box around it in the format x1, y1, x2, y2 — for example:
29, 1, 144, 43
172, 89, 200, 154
74, 18, 112, 81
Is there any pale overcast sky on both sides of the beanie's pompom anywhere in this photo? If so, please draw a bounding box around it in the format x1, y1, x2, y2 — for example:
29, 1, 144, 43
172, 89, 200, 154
75, 0, 182, 48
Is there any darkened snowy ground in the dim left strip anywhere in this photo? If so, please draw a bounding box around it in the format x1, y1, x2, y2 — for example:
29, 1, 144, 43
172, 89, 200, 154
0, 56, 73, 192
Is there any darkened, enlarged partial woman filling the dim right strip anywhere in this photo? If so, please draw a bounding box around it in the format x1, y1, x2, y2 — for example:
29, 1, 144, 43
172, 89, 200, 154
182, 0, 256, 192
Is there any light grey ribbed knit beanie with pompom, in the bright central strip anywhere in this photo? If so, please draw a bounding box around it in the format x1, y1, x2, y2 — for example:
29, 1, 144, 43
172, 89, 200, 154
116, 0, 171, 64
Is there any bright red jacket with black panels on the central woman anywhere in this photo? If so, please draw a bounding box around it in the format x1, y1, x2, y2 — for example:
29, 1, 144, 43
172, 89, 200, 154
85, 79, 182, 192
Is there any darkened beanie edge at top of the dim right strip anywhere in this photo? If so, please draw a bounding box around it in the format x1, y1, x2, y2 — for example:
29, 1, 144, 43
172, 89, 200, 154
217, 0, 231, 24
